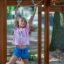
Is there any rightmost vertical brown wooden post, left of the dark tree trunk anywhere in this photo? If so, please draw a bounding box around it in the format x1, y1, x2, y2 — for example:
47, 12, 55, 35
44, 0, 49, 64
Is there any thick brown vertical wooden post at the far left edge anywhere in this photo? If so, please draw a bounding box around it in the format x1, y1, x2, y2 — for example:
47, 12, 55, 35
0, 0, 7, 64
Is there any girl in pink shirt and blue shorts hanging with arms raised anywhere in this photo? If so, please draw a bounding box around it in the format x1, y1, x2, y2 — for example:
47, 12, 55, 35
7, 7, 36, 64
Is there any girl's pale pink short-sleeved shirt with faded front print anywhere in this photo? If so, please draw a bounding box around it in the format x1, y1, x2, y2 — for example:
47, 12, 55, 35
13, 26, 29, 45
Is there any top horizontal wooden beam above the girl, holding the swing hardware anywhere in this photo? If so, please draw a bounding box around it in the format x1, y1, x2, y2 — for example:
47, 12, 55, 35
7, 0, 43, 6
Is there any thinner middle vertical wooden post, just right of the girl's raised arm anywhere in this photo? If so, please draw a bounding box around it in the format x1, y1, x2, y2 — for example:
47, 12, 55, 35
38, 6, 42, 64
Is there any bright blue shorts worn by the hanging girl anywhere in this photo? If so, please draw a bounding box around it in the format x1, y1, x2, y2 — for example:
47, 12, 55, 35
13, 48, 28, 59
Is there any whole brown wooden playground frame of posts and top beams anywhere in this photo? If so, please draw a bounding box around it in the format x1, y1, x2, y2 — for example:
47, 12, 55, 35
0, 0, 64, 64
